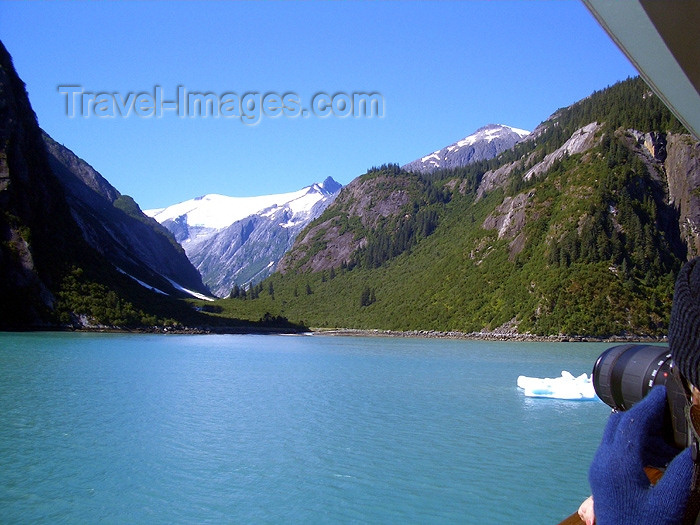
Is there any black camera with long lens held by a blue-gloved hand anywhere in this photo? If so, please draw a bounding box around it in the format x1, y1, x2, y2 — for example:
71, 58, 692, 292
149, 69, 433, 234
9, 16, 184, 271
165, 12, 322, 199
593, 344, 690, 449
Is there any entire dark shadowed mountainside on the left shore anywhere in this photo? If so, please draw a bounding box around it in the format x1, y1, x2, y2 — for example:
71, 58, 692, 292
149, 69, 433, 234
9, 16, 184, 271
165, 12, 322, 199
0, 43, 213, 330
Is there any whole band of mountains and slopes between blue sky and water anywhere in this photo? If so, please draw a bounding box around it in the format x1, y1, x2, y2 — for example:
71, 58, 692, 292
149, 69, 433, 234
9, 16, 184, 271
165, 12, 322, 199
0, 33, 700, 337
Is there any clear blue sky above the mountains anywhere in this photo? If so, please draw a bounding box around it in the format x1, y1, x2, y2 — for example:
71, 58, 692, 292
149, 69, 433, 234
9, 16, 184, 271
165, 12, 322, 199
0, 0, 636, 209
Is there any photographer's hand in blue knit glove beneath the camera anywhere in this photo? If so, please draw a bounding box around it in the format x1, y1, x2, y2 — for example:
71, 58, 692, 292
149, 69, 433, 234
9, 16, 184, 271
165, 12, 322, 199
588, 386, 693, 525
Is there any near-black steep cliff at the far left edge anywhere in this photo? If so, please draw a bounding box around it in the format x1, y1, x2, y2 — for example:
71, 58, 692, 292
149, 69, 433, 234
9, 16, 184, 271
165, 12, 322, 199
0, 43, 86, 328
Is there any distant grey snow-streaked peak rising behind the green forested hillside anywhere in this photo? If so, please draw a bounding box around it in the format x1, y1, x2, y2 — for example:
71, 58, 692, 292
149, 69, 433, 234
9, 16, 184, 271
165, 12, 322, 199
403, 124, 530, 173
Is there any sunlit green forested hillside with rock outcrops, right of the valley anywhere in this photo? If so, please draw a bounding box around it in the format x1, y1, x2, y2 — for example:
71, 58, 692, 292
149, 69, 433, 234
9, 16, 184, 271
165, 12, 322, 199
213, 78, 700, 336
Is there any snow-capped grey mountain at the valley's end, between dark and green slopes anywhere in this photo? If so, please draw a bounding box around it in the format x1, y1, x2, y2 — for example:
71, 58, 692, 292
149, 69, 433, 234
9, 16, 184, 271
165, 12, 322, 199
145, 177, 342, 297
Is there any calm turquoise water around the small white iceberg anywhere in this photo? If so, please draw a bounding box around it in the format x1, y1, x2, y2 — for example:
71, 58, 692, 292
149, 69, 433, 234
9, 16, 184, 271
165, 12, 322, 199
0, 334, 609, 524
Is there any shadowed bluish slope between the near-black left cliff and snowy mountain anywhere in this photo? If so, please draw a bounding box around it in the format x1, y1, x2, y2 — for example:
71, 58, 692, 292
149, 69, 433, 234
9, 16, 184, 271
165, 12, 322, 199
44, 134, 209, 294
